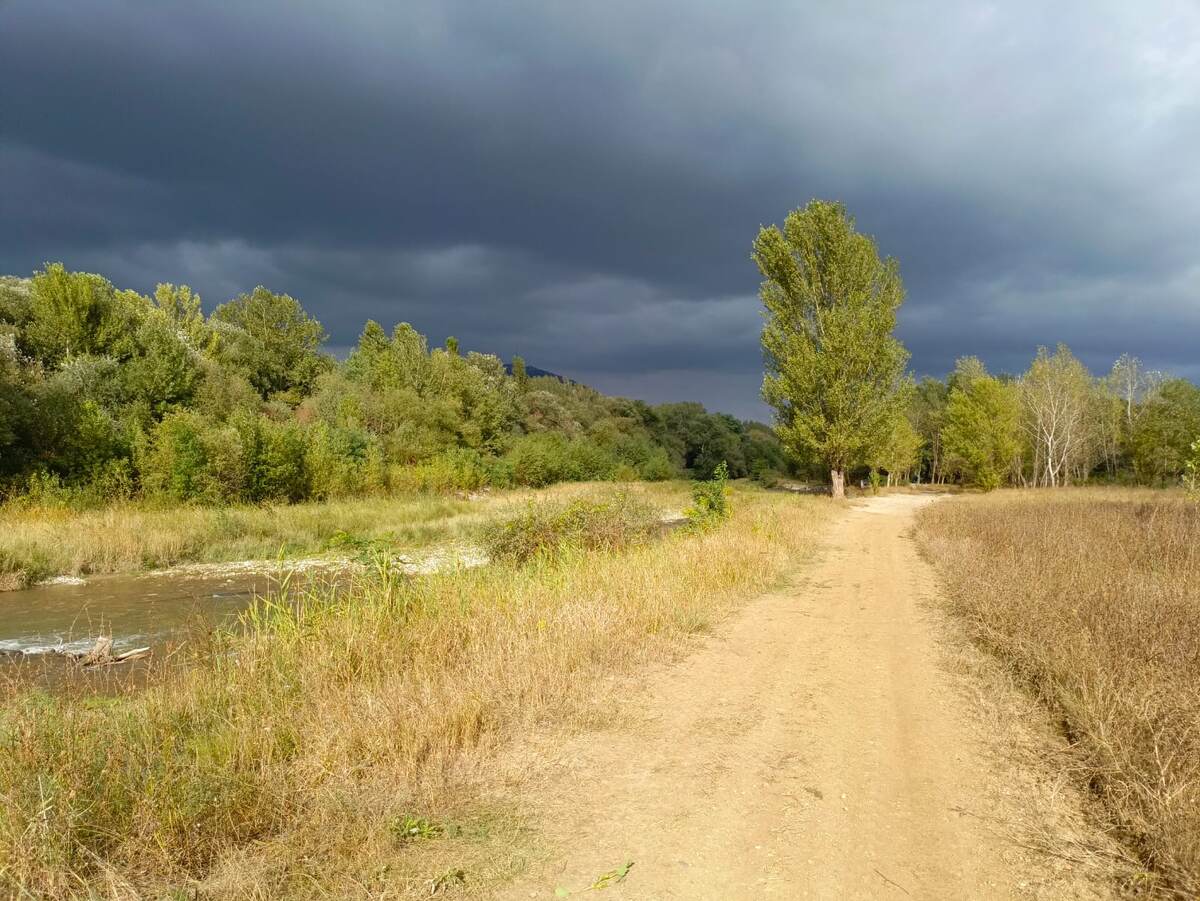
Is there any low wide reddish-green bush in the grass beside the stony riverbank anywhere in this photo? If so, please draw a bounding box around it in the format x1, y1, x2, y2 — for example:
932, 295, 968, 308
482, 492, 659, 563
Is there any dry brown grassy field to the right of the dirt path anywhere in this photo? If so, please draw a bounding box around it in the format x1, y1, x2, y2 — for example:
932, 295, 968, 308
919, 489, 1200, 897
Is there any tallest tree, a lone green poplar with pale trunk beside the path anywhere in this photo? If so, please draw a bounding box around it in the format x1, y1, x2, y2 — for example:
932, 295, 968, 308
754, 200, 908, 497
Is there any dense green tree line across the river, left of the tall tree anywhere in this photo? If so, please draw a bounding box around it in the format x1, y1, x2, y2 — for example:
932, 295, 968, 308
0, 264, 787, 503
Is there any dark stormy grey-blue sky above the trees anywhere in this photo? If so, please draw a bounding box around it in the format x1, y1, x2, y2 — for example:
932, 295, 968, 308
0, 0, 1200, 415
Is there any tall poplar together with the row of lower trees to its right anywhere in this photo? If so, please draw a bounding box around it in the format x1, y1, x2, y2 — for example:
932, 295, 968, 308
752, 200, 1200, 497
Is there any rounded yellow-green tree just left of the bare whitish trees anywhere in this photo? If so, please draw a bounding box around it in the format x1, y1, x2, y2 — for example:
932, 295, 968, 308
942, 358, 1021, 491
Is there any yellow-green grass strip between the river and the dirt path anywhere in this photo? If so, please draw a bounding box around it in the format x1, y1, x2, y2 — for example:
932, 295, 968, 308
0, 487, 834, 899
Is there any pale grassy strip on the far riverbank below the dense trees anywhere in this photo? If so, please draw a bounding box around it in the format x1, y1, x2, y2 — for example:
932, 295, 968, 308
0, 482, 688, 588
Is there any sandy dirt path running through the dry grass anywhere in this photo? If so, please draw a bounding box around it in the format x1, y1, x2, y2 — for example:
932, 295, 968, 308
503, 495, 1100, 901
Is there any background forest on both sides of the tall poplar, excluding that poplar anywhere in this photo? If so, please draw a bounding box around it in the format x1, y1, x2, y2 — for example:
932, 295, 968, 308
0, 264, 1200, 505
